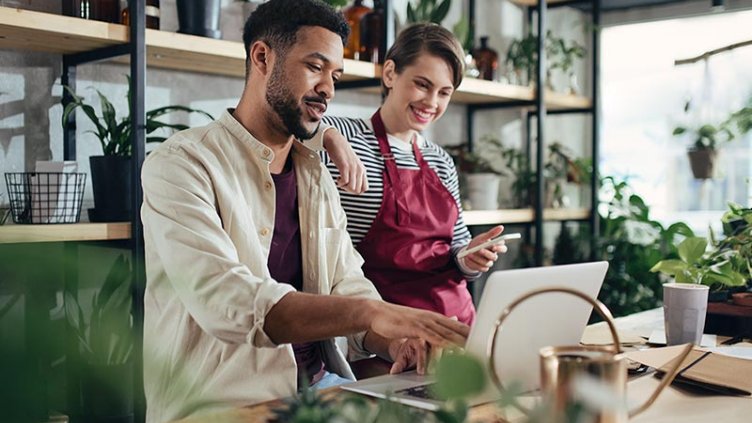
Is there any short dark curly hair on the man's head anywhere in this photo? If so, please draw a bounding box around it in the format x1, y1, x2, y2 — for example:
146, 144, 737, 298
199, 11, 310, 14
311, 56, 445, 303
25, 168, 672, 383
243, 0, 350, 71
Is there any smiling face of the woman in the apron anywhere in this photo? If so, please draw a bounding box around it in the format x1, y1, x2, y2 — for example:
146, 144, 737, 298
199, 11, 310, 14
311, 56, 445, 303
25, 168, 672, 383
383, 52, 454, 132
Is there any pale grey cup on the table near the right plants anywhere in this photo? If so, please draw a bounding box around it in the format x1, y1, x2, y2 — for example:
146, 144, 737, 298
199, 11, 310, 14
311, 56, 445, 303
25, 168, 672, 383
663, 282, 708, 345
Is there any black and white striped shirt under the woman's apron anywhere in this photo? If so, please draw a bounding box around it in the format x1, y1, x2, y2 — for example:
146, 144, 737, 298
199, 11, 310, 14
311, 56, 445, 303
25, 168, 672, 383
321, 116, 478, 278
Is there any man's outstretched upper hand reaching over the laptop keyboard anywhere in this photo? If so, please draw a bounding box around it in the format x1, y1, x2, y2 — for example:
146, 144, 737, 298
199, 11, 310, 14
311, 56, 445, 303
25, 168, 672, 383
363, 301, 470, 350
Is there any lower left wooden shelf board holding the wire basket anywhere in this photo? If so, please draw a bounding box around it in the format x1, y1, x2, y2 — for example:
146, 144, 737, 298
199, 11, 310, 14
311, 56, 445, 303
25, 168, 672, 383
0, 222, 131, 244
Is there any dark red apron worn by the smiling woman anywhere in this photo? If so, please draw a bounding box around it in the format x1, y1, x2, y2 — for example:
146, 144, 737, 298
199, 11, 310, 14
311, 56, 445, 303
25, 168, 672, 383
358, 111, 475, 324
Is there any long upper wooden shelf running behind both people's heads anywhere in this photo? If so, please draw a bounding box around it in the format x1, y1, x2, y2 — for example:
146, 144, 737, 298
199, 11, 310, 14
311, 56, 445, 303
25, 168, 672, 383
0, 7, 591, 110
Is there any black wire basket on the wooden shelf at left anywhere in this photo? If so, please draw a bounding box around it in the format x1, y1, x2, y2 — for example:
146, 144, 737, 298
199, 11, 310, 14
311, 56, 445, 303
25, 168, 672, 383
5, 172, 86, 224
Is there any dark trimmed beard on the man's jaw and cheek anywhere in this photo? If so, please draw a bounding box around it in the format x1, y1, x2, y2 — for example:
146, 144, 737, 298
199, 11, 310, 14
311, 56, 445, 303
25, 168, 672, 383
266, 63, 321, 140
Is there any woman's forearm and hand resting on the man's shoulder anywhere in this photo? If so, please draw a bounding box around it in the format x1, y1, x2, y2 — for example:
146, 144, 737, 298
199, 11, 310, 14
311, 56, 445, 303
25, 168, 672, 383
324, 128, 368, 194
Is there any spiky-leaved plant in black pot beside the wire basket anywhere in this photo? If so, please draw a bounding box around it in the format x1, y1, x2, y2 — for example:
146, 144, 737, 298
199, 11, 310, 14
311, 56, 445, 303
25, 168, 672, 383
62, 78, 214, 222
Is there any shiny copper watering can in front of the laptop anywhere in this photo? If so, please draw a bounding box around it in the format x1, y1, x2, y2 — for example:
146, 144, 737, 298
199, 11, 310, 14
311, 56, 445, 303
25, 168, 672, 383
486, 287, 692, 423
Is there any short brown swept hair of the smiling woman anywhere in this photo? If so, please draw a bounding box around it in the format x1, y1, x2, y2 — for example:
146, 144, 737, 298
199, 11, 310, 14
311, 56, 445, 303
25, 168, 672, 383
381, 23, 465, 97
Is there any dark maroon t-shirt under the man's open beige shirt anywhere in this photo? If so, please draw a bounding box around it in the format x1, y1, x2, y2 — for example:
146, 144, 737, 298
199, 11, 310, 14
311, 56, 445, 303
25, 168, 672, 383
267, 160, 324, 384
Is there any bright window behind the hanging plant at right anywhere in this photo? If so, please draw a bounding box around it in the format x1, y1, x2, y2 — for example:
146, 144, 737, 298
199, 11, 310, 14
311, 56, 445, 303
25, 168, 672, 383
601, 11, 752, 234
